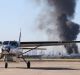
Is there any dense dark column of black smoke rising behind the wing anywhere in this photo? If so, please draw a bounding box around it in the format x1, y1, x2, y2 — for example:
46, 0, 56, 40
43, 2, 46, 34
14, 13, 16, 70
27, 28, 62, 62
48, 0, 79, 54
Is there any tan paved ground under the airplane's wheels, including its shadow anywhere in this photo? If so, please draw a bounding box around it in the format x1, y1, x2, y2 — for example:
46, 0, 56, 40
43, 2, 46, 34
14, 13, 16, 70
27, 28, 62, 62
0, 61, 80, 75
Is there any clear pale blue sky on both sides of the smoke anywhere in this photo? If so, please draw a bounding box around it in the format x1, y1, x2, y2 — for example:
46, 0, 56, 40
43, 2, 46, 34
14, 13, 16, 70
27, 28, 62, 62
0, 0, 80, 41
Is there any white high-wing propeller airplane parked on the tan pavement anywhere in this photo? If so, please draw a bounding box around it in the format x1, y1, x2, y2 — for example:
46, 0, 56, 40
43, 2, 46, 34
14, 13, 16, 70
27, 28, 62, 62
0, 32, 80, 68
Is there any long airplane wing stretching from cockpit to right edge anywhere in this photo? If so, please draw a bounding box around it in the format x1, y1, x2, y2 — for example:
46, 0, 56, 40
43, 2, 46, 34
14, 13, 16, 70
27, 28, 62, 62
20, 41, 80, 47
